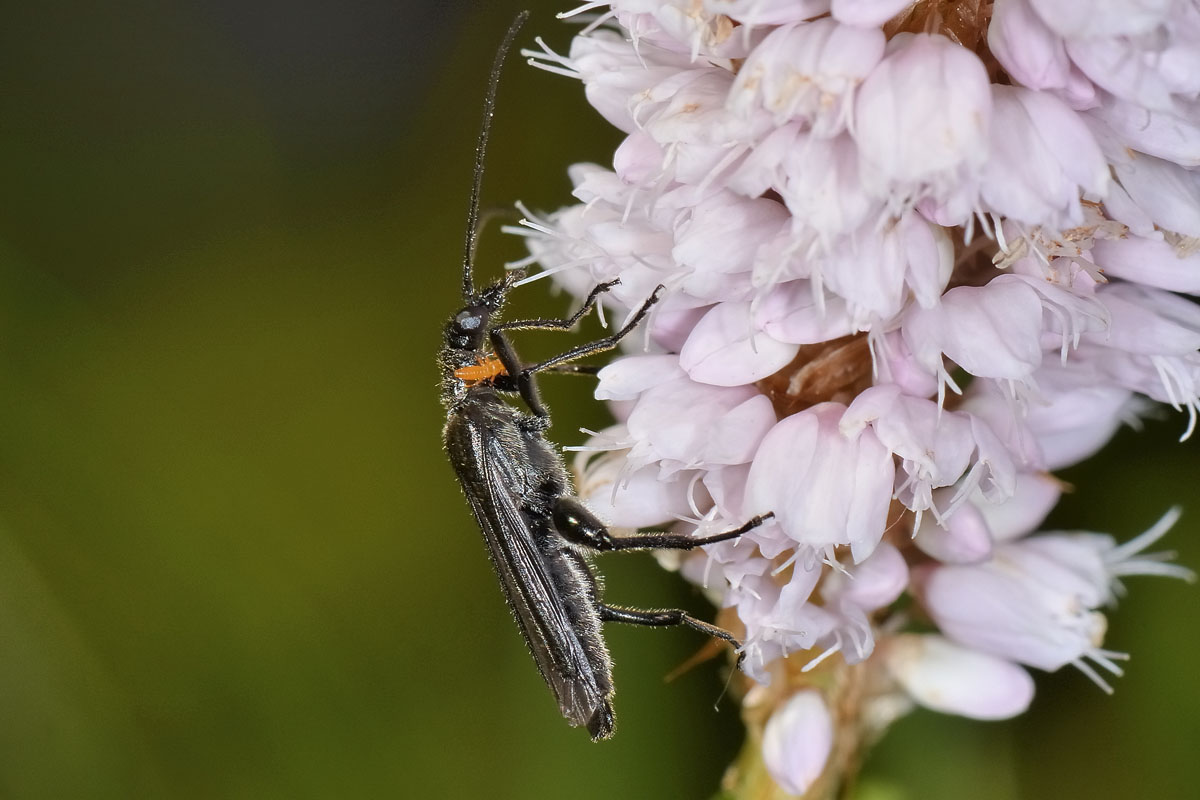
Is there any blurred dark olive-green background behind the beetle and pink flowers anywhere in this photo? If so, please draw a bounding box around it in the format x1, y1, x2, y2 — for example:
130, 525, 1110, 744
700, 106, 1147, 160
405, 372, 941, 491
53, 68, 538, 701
0, 0, 1200, 800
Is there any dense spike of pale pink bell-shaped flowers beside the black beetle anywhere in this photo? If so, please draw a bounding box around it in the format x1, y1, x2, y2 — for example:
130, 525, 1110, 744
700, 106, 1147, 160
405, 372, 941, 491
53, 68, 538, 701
511, 0, 1200, 792
